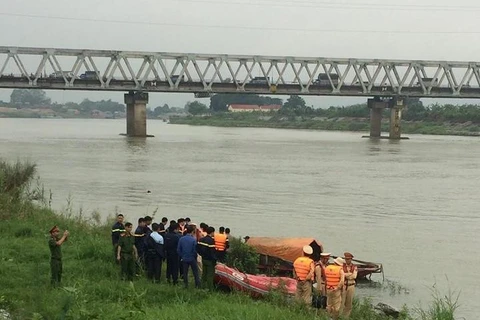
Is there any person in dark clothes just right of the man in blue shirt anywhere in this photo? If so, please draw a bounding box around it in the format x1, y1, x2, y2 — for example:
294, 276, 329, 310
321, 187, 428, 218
197, 227, 217, 290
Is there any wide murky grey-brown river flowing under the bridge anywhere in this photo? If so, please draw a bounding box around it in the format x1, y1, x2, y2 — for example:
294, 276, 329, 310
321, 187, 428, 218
0, 119, 480, 320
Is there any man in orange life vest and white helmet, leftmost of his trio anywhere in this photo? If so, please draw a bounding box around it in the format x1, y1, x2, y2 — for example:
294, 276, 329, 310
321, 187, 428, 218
293, 246, 315, 306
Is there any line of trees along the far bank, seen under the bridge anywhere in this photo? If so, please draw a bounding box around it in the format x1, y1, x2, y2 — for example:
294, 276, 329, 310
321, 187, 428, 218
5, 89, 480, 123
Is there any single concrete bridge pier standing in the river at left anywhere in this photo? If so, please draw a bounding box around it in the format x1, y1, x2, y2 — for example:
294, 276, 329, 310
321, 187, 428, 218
125, 91, 148, 137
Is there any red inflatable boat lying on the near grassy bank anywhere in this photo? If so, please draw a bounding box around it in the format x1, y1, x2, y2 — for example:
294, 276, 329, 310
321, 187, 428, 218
215, 263, 297, 298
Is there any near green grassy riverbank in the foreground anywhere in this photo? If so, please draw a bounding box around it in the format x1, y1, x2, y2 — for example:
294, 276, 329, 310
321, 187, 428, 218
0, 163, 453, 320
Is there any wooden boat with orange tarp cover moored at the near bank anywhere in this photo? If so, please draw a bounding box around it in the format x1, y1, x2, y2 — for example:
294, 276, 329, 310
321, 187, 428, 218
245, 237, 383, 280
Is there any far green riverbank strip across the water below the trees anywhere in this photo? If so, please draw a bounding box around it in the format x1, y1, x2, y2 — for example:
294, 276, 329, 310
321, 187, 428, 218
170, 113, 480, 136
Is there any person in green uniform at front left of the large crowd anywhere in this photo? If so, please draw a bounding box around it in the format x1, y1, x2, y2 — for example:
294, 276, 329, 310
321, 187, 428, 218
117, 222, 138, 281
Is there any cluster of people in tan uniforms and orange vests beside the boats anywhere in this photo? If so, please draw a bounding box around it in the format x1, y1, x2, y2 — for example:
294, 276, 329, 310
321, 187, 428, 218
293, 246, 358, 319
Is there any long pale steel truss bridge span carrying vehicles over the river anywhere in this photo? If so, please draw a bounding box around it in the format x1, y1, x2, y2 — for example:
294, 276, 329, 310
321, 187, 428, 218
0, 47, 480, 98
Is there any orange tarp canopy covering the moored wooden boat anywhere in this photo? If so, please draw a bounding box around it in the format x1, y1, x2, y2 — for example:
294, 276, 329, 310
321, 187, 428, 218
246, 237, 323, 262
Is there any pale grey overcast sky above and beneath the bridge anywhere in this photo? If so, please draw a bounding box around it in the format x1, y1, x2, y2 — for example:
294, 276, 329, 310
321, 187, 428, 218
0, 0, 480, 107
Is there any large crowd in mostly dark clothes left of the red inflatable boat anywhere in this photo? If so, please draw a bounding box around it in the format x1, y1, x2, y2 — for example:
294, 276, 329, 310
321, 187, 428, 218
112, 214, 230, 289
